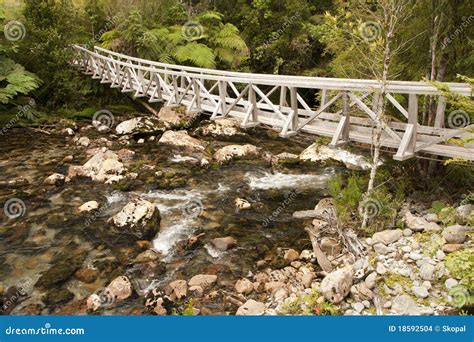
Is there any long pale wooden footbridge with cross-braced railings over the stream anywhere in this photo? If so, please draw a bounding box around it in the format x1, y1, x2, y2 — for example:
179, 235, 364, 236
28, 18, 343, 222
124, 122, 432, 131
74, 45, 474, 160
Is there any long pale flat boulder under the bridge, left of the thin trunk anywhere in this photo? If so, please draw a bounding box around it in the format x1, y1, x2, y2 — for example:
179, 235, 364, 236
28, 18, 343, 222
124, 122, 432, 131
299, 143, 371, 170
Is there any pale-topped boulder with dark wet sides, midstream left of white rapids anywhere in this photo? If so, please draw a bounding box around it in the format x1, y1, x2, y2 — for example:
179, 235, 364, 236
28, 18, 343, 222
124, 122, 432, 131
109, 199, 160, 240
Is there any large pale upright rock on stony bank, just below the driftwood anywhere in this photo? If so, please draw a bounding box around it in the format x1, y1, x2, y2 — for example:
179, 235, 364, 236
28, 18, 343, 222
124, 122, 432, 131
319, 268, 353, 304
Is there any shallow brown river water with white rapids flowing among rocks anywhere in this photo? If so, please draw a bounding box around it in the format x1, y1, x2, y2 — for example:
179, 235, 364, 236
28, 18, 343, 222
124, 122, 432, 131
0, 129, 344, 314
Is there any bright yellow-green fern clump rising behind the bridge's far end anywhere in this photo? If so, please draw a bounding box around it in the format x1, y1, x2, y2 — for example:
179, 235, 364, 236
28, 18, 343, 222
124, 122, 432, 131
101, 9, 247, 68
